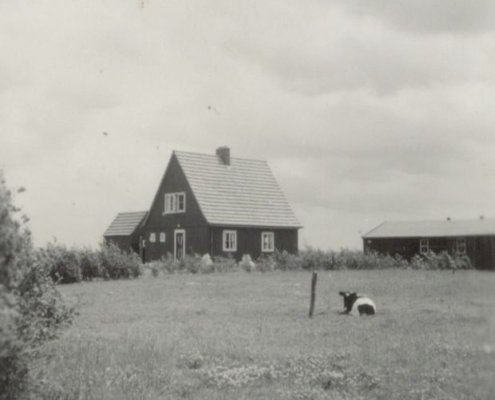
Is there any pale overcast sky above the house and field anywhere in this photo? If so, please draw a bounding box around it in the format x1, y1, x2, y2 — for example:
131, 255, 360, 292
0, 0, 495, 249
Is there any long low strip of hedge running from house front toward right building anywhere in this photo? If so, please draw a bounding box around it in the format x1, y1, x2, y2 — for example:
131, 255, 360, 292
147, 247, 473, 276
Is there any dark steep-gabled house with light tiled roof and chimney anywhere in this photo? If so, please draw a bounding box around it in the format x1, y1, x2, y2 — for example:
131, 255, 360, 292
105, 147, 301, 261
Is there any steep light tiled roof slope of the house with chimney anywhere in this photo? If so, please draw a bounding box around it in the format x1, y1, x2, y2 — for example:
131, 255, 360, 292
174, 151, 301, 228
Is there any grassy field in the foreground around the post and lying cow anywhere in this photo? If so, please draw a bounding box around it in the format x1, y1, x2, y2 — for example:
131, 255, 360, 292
32, 270, 495, 400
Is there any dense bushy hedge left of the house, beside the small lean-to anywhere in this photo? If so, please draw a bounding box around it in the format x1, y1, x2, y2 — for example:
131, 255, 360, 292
36, 243, 141, 283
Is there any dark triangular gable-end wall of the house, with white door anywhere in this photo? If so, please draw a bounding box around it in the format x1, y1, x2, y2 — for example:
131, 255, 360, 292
142, 155, 209, 261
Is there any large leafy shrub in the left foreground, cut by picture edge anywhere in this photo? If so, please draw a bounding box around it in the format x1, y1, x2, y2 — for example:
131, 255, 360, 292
0, 173, 73, 400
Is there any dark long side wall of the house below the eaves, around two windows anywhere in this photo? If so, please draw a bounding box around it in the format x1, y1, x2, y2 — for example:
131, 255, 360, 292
211, 227, 298, 260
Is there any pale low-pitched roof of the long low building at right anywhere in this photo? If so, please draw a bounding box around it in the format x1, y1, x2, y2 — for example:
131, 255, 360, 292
363, 218, 495, 239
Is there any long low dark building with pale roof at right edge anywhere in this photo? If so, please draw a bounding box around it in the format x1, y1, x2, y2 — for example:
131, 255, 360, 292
362, 217, 495, 269
